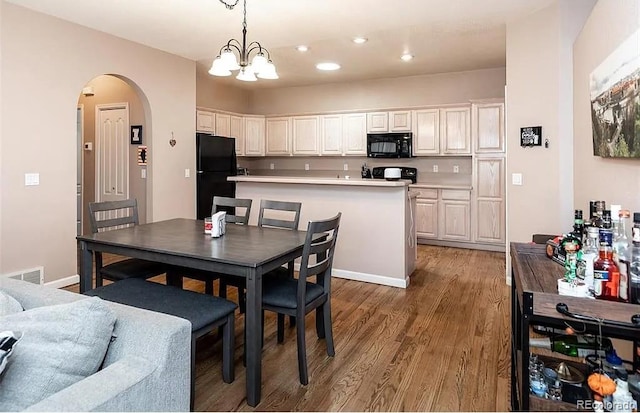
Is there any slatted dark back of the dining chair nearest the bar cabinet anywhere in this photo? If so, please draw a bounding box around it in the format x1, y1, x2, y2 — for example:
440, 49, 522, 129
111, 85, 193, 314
298, 212, 342, 296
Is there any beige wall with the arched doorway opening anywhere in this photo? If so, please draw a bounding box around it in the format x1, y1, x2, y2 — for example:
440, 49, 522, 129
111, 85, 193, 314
0, 3, 196, 282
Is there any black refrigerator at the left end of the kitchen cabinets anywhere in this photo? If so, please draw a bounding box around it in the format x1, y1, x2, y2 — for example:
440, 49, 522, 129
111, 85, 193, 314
196, 133, 238, 219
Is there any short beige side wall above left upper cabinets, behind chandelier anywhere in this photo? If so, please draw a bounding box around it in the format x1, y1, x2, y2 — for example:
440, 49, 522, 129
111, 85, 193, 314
194, 64, 251, 112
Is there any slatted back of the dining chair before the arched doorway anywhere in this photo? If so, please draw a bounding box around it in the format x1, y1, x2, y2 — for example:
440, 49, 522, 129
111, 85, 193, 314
89, 198, 138, 234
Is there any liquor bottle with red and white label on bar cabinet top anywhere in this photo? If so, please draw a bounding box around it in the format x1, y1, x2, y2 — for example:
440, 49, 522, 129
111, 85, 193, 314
593, 214, 620, 301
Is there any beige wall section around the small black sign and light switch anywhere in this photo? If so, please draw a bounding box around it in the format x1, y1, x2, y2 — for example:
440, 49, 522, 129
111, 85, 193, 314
506, 0, 593, 251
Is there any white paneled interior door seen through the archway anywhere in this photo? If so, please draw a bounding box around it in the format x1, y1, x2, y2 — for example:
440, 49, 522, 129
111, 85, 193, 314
96, 103, 129, 208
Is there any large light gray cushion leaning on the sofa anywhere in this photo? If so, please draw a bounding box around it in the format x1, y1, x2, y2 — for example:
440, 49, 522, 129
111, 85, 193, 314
0, 297, 116, 411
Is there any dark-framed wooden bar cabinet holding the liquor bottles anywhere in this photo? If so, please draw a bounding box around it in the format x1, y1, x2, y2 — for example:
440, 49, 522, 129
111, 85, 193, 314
510, 243, 640, 411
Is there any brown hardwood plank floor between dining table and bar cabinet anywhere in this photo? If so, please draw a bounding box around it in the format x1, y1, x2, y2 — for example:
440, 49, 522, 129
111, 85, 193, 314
70, 245, 510, 411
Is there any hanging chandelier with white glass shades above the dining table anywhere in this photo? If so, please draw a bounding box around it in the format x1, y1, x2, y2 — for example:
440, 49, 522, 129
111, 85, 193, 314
209, 0, 278, 82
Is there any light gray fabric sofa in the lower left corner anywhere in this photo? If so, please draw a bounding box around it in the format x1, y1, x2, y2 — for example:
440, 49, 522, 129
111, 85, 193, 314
0, 279, 191, 411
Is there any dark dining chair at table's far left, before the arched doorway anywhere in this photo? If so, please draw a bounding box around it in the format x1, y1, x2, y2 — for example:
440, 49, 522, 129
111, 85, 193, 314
89, 199, 168, 287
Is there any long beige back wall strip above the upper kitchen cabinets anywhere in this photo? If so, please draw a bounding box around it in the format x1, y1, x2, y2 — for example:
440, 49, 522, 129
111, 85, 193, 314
250, 68, 505, 115
